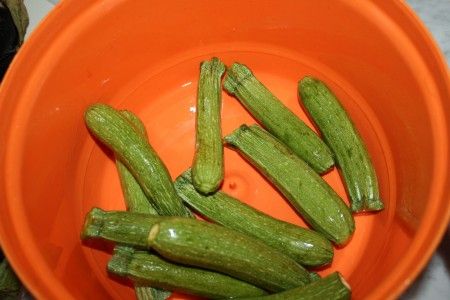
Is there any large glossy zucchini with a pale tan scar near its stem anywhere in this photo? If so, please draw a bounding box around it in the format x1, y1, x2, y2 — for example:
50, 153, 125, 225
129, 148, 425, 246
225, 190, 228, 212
82, 208, 312, 292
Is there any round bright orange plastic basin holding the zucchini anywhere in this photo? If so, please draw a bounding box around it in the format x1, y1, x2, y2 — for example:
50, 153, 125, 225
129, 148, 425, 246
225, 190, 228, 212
0, 0, 450, 299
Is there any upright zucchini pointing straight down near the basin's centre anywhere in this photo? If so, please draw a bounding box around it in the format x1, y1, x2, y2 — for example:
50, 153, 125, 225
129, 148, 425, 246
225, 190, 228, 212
192, 57, 225, 194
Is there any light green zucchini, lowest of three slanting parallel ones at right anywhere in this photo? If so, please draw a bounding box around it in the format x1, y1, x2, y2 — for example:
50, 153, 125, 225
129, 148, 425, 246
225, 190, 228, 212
225, 125, 355, 245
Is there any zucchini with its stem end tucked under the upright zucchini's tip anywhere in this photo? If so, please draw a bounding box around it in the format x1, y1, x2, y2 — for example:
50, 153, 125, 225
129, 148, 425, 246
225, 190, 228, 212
175, 170, 333, 266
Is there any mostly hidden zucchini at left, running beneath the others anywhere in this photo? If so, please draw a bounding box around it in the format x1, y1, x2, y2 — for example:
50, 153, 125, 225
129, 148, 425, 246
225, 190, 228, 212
116, 110, 171, 300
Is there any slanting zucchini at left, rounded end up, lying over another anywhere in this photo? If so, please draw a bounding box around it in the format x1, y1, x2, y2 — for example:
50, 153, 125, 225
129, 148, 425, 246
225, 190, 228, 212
85, 103, 189, 216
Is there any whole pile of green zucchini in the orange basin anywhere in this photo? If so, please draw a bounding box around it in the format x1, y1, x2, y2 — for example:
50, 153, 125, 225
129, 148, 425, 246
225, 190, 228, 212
81, 58, 383, 300
